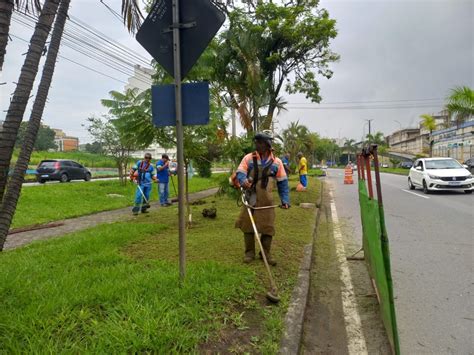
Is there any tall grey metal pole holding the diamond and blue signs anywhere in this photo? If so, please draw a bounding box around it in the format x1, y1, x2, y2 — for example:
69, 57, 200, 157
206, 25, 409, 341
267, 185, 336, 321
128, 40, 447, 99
173, 0, 186, 282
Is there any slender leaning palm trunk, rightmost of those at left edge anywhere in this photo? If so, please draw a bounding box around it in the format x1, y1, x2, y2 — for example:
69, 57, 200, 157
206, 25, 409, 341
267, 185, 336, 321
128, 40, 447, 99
0, 0, 70, 250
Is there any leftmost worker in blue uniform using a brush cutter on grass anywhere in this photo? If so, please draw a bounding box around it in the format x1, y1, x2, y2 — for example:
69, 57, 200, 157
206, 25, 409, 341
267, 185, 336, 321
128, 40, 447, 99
130, 153, 157, 215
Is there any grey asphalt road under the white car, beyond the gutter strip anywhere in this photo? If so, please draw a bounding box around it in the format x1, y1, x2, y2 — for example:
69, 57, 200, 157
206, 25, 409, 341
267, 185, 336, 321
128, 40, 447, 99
327, 169, 474, 354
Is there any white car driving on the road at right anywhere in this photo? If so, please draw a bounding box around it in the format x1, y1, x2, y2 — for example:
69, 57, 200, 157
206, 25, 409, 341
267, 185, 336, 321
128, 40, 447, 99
408, 158, 474, 194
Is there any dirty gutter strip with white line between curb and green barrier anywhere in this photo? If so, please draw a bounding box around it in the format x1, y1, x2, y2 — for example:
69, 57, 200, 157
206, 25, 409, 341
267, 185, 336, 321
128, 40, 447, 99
301, 181, 390, 354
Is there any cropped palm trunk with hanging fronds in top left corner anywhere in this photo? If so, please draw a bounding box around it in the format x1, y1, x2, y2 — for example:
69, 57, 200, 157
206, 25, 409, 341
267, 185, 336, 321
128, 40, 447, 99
0, 0, 41, 71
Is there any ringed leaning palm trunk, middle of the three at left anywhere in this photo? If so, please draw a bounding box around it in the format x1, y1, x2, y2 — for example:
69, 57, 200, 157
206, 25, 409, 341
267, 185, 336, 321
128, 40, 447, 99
0, 0, 60, 201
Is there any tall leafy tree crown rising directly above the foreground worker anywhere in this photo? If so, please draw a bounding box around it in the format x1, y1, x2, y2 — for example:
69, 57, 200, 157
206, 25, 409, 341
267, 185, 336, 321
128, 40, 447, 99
215, 0, 339, 131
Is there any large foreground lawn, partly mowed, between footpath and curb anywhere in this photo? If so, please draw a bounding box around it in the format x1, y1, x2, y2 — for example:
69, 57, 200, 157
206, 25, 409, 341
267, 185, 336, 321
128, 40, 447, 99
0, 179, 319, 354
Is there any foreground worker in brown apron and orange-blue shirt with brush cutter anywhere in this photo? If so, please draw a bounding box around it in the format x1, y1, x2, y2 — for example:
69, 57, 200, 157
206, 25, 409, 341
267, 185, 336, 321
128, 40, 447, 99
235, 132, 290, 302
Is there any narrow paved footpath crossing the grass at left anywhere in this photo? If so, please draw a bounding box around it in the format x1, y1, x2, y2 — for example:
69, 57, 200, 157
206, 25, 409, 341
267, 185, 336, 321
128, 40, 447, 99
4, 188, 218, 250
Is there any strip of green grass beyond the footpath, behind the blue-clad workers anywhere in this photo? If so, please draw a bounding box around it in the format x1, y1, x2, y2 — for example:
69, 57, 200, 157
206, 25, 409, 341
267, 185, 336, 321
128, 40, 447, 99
12, 174, 219, 228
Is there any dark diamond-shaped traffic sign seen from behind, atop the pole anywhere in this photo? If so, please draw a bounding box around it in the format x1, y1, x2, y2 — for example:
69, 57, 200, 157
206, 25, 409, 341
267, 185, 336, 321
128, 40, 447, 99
136, 0, 225, 78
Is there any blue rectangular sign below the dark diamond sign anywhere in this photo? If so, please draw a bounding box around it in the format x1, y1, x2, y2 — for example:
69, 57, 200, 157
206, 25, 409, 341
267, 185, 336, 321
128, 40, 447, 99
151, 82, 209, 127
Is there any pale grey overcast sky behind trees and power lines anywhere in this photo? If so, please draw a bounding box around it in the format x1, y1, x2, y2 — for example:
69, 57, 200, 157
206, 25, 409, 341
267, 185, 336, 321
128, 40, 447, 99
0, 0, 474, 142
